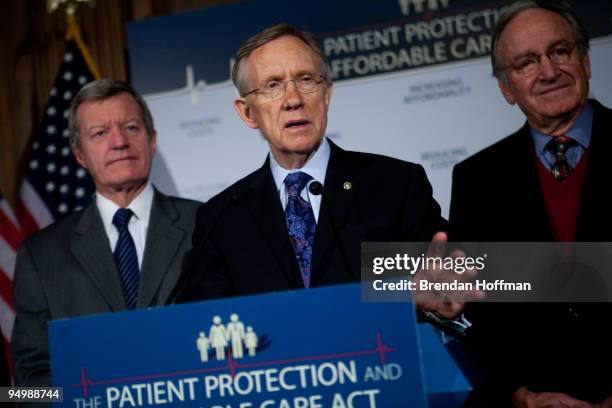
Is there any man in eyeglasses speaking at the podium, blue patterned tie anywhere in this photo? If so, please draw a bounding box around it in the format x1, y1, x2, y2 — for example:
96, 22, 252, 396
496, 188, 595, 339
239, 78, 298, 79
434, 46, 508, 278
176, 24, 445, 302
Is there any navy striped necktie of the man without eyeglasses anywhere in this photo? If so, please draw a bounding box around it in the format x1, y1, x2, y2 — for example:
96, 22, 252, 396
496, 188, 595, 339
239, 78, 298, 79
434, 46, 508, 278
113, 208, 139, 309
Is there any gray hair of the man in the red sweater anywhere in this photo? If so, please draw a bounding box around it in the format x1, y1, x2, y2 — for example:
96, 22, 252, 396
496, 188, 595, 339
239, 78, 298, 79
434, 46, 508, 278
491, 0, 589, 79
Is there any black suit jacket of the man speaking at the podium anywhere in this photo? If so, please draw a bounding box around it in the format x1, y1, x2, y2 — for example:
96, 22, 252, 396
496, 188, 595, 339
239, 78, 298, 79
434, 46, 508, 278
176, 142, 445, 302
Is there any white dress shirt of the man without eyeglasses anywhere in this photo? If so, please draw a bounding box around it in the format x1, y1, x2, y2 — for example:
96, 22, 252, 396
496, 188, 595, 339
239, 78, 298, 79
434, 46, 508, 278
96, 182, 153, 268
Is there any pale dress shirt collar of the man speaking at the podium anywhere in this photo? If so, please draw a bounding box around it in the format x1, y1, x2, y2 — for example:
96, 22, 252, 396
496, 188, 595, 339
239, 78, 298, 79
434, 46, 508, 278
270, 137, 330, 222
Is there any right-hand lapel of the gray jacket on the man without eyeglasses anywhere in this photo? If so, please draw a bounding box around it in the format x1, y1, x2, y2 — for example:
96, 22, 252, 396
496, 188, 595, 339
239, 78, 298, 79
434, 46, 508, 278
138, 190, 186, 307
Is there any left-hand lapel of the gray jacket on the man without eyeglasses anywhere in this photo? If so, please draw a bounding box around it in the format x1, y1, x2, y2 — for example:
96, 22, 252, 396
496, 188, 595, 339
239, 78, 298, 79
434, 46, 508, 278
70, 203, 126, 312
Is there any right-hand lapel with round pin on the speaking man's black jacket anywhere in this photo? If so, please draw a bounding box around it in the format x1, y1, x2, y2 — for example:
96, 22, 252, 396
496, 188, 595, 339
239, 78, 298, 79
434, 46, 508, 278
312, 141, 359, 273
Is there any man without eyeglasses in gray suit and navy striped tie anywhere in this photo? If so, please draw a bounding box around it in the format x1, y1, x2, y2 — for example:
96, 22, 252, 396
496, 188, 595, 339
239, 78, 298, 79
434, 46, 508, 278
12, 79, 199, 386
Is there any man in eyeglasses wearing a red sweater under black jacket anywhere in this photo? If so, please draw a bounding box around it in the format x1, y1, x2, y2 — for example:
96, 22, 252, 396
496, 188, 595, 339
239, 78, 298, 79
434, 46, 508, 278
450, 0, 612, 407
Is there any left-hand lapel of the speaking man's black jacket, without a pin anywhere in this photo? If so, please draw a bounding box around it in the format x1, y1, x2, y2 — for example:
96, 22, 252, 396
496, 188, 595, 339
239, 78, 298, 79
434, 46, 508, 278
247, 159, 303, 287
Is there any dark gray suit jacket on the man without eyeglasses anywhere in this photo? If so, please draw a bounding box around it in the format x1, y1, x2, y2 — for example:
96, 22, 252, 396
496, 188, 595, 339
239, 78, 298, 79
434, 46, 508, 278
12, 191, 200, 386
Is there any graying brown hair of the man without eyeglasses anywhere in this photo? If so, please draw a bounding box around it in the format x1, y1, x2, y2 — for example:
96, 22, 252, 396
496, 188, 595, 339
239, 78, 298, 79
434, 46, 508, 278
68, 78, 155, 147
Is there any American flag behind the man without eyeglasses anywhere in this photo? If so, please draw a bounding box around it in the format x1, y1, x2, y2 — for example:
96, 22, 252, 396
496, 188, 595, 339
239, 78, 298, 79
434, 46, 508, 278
0, 20, 99, 358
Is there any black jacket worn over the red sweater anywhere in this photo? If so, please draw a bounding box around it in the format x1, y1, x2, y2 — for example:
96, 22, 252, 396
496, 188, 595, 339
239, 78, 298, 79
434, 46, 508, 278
450, 101, 612, 406
